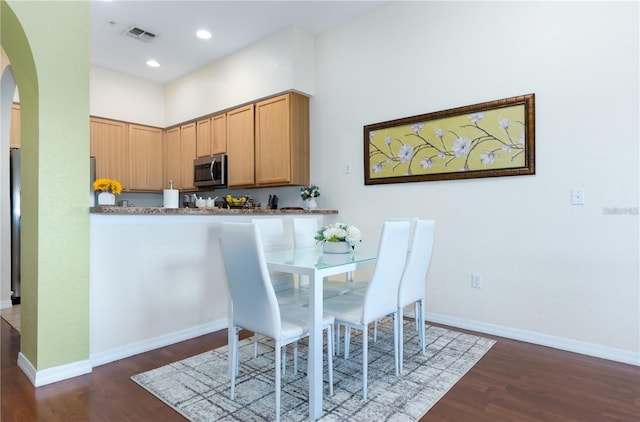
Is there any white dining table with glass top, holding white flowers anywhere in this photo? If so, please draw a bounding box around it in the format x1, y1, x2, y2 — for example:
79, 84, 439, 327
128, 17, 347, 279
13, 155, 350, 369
265, 244, 378, 420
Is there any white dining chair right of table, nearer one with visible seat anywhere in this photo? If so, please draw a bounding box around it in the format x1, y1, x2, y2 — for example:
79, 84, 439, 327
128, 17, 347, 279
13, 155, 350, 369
324, 221, 411, 400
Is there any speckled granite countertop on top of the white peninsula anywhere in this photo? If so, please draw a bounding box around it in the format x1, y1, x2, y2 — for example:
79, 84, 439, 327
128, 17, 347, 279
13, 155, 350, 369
89, 206, 338, 215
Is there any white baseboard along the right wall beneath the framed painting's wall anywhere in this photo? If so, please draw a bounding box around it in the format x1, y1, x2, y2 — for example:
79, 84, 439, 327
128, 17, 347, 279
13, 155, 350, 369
425, 312, 640, 366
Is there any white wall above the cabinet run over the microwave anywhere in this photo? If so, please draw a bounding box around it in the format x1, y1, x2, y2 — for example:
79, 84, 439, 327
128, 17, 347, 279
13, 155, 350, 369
166, 27, 314, 126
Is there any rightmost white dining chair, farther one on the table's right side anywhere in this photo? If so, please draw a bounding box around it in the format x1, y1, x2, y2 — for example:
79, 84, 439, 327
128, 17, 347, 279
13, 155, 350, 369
397, 220, 436, 374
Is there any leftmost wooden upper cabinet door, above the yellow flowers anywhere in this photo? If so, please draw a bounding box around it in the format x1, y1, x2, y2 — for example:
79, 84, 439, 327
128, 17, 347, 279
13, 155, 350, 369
90, 117, 131, 191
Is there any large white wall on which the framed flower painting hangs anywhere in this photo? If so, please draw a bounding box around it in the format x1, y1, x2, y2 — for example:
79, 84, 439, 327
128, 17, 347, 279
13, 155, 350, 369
311, 2, 640, 360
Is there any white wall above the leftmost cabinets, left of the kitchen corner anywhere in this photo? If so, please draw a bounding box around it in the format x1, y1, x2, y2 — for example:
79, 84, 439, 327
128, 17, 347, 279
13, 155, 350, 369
89, 66, 165, 127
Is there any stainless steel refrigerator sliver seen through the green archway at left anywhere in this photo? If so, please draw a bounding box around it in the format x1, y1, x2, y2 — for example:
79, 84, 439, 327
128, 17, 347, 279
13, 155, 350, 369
9, 148, 20, 305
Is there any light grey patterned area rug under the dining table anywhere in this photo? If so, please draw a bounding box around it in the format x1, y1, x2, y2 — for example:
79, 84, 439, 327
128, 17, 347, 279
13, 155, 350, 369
131, 318, 495, 422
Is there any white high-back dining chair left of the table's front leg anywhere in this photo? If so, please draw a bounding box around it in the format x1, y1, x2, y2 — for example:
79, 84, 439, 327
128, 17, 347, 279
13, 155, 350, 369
220, 223, 334, 421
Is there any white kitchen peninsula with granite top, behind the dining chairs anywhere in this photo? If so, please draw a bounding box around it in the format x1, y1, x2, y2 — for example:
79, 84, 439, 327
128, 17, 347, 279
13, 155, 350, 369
90, 206, 338, 366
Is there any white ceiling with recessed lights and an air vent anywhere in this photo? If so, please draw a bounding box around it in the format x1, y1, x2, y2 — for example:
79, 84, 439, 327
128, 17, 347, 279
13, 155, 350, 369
90, 0, 388, 85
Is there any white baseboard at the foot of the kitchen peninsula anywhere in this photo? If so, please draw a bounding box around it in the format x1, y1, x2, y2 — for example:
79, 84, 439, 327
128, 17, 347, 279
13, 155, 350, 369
90, 319, 228, 367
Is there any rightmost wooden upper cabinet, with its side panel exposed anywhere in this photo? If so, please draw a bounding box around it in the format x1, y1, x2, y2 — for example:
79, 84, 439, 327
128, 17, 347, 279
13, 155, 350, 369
255, 93, 309, 186
